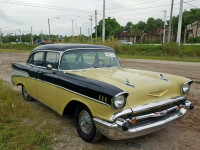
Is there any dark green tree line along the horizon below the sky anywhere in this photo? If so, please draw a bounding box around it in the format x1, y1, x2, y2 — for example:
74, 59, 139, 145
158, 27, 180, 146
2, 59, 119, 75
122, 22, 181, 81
2, 9, 200, 43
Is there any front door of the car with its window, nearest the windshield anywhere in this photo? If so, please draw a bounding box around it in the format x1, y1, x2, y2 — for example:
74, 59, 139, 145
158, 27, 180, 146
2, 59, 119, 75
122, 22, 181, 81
37, 51, 59, 110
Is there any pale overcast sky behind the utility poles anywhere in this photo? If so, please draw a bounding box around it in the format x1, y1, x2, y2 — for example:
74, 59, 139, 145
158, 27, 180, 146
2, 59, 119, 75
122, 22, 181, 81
0, 0, 200, 36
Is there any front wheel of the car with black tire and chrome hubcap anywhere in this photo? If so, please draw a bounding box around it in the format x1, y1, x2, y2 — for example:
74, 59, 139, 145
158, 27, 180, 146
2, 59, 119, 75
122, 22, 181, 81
75, 106, 102, 142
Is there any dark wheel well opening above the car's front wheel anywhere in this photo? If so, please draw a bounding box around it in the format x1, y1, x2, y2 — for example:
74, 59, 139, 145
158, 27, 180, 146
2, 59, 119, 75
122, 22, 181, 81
63, 100, 89, 115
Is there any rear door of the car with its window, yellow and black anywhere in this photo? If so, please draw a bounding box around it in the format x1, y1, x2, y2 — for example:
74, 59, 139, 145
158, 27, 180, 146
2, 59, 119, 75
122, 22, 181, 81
26, 51, 44, 99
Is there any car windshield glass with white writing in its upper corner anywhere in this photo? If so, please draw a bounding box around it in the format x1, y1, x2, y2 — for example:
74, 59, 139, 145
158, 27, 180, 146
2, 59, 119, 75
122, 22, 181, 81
60, 50, 120, 70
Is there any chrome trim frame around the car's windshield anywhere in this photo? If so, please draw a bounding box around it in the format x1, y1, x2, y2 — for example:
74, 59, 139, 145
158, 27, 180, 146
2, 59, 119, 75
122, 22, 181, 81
58, 48, 122, 73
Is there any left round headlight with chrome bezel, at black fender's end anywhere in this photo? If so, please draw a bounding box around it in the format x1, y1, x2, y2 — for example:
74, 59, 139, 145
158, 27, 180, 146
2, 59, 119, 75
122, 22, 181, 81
111, 92, 129, 110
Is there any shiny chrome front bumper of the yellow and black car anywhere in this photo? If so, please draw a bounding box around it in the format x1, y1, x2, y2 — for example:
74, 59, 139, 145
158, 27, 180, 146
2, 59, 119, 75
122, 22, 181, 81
94, 96, 192, 140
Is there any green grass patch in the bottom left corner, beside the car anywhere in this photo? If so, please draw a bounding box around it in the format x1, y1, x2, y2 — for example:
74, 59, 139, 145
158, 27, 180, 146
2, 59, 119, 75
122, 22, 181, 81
0, 80, 52, 150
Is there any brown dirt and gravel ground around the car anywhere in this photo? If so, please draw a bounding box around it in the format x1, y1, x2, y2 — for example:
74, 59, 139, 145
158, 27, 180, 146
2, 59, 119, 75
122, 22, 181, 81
0, 53, 200, 150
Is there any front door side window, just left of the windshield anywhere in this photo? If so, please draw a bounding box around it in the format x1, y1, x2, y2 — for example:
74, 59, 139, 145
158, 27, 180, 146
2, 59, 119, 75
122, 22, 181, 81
45, 52, 60, 68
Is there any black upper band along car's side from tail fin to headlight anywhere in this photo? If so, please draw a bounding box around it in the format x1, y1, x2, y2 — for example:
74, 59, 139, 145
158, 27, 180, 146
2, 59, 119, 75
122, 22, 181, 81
12, 63, 123, 104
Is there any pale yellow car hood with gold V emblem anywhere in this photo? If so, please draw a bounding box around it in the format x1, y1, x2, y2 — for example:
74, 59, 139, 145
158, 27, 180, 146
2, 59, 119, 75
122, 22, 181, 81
71, 68, 188, 108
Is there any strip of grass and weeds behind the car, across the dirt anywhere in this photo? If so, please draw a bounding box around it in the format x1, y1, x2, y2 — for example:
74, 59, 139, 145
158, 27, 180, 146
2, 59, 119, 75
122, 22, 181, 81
0, 40, 200, 62
